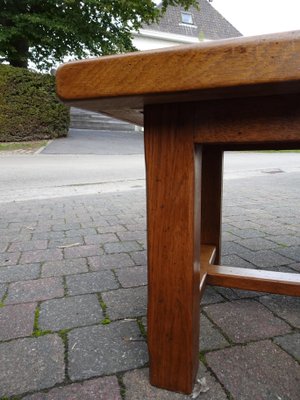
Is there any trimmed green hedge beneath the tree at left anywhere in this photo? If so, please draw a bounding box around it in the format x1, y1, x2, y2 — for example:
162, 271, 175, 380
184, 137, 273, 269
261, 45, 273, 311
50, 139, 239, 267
0, 65, 70, 142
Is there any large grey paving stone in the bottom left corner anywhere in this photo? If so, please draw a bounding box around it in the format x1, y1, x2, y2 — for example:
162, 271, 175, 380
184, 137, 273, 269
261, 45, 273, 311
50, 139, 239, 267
0, 335, 65, 397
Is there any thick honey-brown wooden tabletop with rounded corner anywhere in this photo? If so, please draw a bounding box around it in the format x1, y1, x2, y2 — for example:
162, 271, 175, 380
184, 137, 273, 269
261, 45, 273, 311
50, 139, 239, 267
56, 31, 300, 123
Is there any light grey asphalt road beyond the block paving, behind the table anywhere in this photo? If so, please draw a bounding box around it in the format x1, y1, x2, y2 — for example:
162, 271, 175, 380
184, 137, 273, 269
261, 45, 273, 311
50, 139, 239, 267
0, 129, 300, 202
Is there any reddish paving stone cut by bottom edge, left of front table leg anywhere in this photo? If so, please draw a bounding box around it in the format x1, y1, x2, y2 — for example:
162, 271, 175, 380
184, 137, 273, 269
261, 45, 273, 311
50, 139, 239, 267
23, 376, 122, 400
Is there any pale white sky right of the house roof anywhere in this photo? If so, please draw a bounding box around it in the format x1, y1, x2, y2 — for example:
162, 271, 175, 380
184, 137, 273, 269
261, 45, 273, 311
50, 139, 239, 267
211, 0, 300, 36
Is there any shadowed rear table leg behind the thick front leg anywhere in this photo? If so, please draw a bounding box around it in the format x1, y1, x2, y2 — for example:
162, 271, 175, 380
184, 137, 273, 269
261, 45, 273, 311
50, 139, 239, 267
201, 146, 223, 264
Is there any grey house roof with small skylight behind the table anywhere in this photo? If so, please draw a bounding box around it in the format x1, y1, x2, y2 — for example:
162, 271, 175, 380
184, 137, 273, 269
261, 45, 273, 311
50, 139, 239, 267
144, 0, 242, 40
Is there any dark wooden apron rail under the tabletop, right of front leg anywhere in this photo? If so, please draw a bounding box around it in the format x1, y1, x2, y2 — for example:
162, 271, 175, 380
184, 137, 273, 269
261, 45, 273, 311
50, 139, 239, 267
194, 94, 300, 146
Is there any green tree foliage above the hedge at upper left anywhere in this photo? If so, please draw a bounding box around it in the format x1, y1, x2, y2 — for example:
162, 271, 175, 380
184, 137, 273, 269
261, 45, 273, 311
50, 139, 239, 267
0, 0, 197, 69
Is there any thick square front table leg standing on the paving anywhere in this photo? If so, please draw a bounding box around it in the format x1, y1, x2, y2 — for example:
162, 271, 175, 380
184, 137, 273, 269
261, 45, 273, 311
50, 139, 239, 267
145, 104, 201, 393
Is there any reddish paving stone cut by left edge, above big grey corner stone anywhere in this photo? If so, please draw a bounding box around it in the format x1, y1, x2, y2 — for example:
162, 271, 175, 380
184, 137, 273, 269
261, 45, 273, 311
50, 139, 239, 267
0, 303, 36, 340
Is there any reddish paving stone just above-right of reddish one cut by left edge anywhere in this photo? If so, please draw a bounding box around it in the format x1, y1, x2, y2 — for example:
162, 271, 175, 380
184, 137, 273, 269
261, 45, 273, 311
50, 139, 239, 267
5, 278, 64, 304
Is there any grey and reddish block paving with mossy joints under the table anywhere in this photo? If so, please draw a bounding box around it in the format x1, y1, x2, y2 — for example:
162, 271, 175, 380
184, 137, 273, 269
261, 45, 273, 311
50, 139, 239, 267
0, 173, 300, 400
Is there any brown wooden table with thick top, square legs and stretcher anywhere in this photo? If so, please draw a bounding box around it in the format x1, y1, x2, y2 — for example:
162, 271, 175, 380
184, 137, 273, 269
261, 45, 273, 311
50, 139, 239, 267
57, 31, 300, 393
